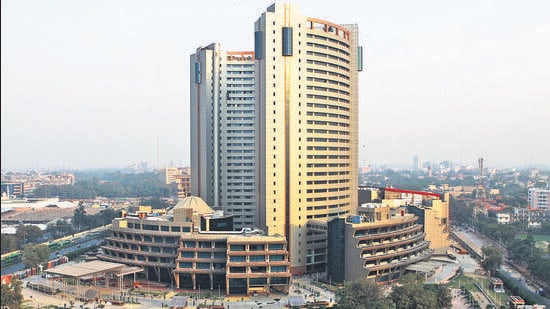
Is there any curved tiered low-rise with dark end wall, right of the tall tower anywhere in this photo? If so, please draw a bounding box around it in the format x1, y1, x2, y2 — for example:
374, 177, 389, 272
327, 205, 433, 284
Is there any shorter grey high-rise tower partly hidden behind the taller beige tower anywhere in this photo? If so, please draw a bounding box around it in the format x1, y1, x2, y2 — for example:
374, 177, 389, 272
190, 43, 259, 229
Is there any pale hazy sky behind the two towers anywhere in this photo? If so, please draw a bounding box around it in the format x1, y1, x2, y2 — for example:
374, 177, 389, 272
1, 0, 550, 169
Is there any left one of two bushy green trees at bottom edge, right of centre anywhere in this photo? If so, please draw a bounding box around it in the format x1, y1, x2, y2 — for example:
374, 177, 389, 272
336, 280, 391, 309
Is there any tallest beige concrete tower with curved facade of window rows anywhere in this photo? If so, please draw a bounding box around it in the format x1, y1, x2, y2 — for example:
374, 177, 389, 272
254, 3, 362, 273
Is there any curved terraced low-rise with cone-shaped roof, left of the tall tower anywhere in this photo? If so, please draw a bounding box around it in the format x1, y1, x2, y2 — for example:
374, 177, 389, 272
98, 197, 291, 294
